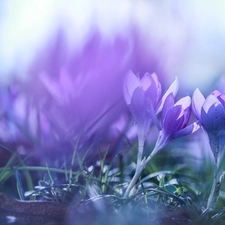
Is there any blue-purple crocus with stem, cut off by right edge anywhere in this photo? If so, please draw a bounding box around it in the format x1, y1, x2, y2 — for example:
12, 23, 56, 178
192, 89, 225, 210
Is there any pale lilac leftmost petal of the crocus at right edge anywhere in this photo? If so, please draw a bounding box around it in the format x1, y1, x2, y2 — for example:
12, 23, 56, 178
192, 88, 205, 120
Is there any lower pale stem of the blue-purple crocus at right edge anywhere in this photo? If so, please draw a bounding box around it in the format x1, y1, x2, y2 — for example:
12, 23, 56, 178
207, 166, 224, 210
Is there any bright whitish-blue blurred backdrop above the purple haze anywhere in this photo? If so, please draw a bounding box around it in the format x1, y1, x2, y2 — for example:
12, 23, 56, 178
0, 0, 225, 89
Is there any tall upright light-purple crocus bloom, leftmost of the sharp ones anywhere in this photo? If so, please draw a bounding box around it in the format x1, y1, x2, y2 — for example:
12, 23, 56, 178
124, 71, 161, 163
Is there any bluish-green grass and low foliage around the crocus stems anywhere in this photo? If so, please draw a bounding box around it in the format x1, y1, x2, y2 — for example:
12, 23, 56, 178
0, 140, 225, 225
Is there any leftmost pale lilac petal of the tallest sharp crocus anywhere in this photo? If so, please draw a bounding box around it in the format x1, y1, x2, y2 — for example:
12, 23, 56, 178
123, 71, 141, 105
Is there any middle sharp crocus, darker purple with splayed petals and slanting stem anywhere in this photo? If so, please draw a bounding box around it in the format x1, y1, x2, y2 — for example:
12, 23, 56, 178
125, 92, 199, 200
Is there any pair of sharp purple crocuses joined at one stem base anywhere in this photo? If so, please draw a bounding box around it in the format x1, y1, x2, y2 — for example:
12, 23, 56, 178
124, 71, 199, 198
